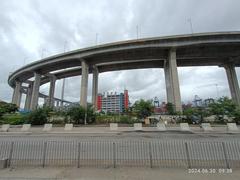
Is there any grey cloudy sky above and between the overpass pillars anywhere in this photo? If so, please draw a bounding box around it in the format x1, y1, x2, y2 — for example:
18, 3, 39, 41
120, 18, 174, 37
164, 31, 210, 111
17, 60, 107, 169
0, 0, 240, 107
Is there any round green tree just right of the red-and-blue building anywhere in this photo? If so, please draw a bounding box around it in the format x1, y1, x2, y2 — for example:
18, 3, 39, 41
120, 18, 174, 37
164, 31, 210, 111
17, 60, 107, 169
133, 99, 154, 119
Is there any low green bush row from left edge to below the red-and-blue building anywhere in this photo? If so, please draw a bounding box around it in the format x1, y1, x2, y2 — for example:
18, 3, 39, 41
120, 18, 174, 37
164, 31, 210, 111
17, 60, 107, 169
0, 107, 140, 125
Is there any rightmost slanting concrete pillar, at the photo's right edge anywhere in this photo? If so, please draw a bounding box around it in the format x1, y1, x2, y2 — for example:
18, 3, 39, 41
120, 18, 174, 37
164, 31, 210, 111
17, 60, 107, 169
224, 64, 240, 105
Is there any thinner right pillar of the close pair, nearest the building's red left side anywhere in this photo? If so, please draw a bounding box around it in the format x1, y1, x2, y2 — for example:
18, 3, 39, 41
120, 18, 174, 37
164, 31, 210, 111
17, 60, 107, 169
92, 66, 98, 110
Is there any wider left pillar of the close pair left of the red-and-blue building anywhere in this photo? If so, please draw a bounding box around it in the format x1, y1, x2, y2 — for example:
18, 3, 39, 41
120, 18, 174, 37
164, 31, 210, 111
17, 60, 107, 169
80, 60, 89, 108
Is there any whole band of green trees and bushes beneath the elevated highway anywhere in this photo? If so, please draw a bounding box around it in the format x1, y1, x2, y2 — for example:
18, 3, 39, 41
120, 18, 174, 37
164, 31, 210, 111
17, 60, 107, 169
0, 97, 240, 125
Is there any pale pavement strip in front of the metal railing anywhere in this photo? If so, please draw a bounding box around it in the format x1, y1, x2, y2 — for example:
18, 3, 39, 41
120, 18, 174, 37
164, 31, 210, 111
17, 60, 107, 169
0, 167, 240, 180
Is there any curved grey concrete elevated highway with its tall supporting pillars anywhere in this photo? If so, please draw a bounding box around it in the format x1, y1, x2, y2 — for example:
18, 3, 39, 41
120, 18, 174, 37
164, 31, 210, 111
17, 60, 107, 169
9, 32, 240, 111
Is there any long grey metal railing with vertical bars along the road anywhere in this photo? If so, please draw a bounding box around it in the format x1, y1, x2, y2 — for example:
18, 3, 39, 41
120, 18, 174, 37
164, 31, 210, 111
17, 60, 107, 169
0, 140, 240, 168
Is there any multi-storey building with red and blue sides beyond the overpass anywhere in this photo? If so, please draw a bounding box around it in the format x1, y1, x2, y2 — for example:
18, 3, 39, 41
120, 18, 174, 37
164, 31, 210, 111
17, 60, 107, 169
97, 90, 129, 113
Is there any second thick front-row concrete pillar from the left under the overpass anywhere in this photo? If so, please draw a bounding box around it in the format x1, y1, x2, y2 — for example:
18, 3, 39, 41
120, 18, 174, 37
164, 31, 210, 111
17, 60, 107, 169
30, 72, 41, 110
